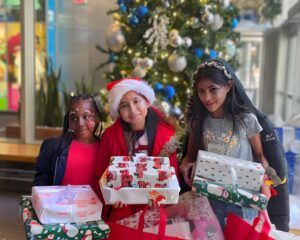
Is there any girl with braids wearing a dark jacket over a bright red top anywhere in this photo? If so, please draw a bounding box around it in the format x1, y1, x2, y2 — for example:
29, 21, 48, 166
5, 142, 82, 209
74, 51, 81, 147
34, 94, 101, 187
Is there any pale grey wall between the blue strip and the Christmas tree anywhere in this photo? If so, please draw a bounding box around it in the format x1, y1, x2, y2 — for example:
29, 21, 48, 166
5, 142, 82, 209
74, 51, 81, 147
56, 0, 116, 90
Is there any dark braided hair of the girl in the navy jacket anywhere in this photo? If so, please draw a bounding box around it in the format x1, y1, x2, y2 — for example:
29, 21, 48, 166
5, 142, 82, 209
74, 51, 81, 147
63, 93, 102, 135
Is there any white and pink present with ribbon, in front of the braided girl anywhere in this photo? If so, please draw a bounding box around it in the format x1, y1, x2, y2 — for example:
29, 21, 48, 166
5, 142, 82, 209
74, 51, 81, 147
32, 185, 102, 224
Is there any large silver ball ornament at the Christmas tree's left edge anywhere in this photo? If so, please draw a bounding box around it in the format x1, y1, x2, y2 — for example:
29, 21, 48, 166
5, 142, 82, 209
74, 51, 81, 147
105, 23, 126, 52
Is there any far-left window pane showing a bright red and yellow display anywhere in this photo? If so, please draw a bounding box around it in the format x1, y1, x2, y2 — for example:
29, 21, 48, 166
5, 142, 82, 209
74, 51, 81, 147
0, 1, 22, 139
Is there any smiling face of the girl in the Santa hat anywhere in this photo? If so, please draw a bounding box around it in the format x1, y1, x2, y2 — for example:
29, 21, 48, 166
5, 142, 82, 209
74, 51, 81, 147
119, 91, 150, 130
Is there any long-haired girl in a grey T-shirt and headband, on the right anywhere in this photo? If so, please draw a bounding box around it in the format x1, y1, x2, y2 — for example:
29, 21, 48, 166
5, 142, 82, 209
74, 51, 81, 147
180, 60, 286, 230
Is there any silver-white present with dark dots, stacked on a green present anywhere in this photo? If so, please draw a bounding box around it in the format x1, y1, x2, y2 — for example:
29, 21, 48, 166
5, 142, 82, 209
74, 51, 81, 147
195, 150, 265, 192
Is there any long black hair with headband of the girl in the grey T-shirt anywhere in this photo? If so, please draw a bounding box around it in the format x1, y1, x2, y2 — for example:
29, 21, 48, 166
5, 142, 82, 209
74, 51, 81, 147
186, 59, 263, 158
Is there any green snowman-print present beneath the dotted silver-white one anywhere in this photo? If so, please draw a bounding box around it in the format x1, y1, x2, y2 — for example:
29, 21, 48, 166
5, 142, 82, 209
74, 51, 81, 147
192, 176, 268, 210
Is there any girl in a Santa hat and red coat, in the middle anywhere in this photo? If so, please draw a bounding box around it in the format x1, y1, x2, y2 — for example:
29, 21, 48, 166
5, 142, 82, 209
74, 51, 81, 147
96, 79, 178, 221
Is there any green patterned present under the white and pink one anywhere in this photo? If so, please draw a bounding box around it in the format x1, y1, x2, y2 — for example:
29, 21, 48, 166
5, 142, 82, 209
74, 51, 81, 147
20, 196, 110, 240
